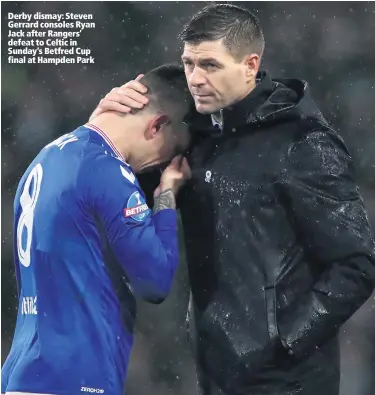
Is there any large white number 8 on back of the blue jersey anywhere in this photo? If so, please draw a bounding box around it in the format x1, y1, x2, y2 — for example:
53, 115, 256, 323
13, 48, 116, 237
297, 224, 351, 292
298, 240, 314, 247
17, 163, 43, 267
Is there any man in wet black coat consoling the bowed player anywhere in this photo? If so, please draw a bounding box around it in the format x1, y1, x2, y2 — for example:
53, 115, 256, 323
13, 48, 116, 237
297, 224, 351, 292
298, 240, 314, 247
91, 5, 375, 395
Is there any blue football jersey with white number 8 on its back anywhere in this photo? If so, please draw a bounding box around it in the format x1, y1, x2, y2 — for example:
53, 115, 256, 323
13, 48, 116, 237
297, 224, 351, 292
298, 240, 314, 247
2, 125, 178, 395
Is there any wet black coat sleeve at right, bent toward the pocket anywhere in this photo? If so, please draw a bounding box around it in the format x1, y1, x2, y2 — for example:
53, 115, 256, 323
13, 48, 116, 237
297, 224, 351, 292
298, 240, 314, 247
278, 131, 375, 356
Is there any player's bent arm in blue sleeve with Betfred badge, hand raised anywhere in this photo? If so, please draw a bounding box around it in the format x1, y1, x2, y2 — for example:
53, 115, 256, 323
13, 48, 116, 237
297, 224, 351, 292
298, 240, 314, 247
91, 155, 188, 303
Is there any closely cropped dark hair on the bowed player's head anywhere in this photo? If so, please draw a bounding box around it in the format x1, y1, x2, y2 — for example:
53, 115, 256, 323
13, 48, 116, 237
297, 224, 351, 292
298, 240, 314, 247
140, 64, 193, 121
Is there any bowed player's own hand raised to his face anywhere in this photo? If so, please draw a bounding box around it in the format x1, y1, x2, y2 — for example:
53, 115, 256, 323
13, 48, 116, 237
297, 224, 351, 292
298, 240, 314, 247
154, 155, 191, 197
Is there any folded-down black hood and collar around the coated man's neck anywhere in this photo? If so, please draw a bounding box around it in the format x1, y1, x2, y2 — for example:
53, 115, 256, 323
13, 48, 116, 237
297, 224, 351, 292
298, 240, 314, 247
189, 71, 327, 133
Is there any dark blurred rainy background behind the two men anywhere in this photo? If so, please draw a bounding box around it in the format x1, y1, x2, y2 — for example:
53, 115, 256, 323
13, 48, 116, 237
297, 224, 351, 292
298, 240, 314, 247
1, 1, 375, 395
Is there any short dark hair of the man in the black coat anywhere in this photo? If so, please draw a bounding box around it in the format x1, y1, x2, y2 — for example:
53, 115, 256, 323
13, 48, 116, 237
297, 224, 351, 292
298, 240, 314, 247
178, 4, 265, 58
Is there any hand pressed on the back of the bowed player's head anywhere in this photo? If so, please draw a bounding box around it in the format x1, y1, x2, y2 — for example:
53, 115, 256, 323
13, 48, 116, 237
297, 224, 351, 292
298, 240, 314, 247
90, 74, 148, 121
